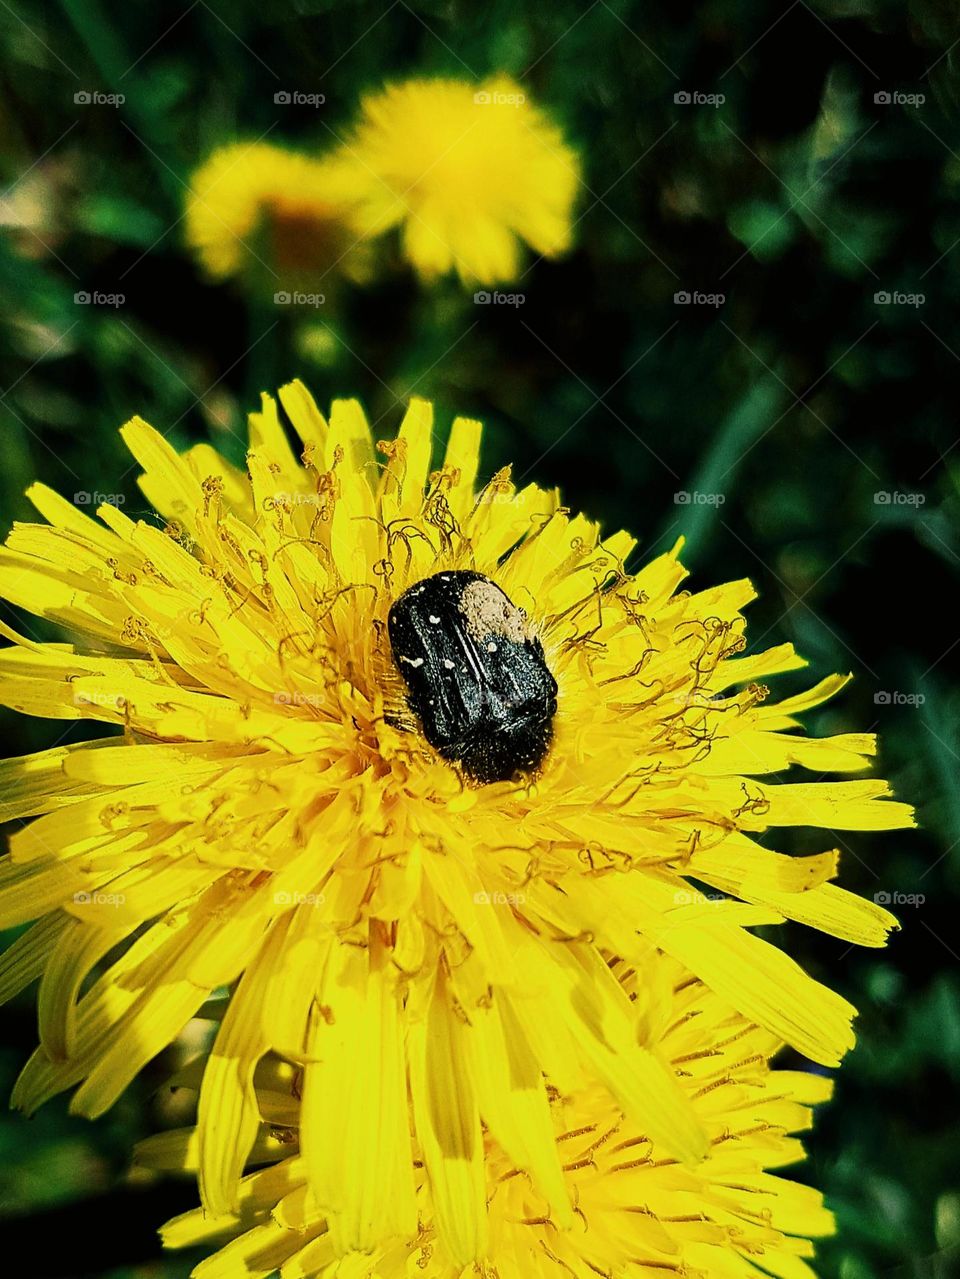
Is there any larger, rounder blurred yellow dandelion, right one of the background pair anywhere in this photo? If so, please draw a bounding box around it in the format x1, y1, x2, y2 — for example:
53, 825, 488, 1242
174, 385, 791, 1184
329, 75, 579, 284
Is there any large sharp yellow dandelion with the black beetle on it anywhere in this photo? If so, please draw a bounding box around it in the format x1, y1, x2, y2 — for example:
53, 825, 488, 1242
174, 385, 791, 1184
0, 382, 911, 1261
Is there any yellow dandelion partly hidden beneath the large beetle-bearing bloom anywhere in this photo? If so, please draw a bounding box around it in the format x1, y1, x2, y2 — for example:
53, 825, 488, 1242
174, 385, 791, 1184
137, 954, 833, 1279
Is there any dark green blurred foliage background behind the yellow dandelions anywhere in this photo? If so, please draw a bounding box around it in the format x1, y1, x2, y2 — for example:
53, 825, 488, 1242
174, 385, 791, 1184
0, 0, 960, 1279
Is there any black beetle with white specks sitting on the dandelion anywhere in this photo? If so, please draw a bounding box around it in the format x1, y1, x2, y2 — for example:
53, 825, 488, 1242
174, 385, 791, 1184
387, 569, 557, 783
